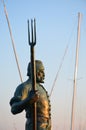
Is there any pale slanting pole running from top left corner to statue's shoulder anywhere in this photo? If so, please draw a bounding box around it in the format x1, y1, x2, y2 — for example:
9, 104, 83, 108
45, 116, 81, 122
2, 0, 23, 82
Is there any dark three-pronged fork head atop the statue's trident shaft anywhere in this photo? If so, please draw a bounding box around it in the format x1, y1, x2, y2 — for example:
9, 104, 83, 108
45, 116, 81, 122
28, 19, 36, 46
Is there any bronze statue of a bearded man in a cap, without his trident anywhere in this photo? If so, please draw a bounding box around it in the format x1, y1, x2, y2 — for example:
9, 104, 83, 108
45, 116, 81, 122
10, 60, 51, 130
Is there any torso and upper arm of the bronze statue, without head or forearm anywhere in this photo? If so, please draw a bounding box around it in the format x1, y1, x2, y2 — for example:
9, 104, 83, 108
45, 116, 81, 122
12, 80, 51, 130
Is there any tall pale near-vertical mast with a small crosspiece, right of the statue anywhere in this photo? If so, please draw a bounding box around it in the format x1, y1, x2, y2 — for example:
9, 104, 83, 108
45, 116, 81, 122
70, 13, 81, 130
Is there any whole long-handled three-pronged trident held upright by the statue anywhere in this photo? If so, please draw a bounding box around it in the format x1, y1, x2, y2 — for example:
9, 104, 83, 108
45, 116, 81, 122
28, 19, 37, 130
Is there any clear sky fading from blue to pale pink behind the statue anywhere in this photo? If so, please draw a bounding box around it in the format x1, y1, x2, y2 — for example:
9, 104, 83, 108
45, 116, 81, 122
0, 0, 86, 130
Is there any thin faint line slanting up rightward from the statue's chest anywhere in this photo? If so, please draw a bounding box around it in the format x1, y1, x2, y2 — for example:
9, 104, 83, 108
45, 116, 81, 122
49, 18, 76, 97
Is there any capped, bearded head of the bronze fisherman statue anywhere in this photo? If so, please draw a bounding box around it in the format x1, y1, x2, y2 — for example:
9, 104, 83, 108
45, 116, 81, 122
27, 60, 45, 83
